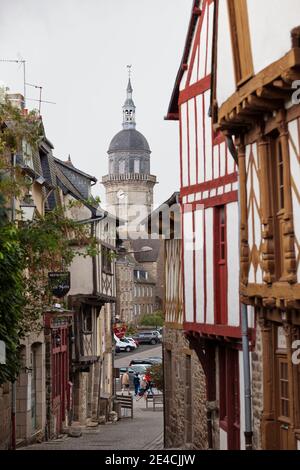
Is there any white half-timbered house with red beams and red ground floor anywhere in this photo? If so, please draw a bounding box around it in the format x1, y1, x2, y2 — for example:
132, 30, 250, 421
166, 0, 252, 449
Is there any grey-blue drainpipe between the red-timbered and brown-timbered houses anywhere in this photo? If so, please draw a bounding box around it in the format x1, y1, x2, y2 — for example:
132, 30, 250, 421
226, 135, 253, 450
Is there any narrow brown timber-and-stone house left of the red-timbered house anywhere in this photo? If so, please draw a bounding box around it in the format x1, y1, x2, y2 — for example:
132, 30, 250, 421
148, 192, 207, 449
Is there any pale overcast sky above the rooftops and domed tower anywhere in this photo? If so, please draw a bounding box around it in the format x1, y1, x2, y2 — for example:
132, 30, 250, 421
0, 0, 192, 204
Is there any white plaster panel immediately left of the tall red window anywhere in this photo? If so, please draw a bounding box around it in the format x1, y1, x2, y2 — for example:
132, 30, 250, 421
205, 208, 215, 324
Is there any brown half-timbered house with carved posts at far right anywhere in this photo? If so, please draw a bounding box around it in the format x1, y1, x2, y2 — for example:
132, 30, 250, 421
211, 0, 300, 449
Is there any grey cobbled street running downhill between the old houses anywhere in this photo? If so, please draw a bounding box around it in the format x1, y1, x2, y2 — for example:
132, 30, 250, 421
21, 346, 163, 450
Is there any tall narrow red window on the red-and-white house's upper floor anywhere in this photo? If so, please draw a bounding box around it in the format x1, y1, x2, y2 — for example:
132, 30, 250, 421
214, 206, 227, 325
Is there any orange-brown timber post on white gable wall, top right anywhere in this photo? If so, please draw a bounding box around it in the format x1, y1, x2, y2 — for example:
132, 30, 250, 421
227, 0, 254, 85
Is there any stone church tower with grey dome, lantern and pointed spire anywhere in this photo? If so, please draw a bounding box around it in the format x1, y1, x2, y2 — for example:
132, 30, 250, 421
102, 67, 156, 227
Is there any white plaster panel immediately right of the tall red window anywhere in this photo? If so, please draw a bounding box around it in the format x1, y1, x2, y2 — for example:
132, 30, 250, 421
226, 202, 240, 326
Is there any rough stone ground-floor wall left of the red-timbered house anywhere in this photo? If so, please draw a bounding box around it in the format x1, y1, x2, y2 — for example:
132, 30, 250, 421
164, 327, 207, 449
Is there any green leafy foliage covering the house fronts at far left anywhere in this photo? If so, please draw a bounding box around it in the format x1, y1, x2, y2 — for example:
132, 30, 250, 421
0, 94, 98, 384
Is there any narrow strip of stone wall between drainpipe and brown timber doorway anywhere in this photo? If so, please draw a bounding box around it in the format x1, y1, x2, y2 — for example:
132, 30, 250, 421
251, 322, 263, 449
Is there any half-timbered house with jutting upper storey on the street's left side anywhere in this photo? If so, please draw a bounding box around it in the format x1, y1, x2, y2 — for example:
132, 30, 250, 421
55, 159, 117, 424
